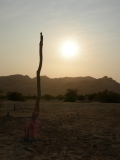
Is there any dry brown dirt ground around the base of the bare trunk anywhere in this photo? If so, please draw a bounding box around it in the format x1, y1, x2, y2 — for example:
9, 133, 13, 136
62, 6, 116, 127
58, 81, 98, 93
0, 101, 120, 160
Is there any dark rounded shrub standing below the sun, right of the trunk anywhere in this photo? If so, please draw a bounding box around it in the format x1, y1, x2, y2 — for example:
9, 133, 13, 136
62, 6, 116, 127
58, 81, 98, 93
64, 89, 77, 102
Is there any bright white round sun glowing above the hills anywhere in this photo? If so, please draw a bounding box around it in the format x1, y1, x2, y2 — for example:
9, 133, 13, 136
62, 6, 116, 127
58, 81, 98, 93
61, 40, 78, 58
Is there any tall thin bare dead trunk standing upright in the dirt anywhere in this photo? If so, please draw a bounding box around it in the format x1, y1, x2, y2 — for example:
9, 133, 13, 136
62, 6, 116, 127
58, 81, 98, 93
25, 33, 43, 141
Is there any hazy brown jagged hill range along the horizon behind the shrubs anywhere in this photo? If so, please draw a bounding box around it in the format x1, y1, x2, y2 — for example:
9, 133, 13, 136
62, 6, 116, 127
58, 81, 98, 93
0, 75, 120, 95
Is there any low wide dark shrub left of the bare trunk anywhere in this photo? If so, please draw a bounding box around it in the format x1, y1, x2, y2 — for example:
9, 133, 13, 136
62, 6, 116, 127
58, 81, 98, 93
7, 92, 25, 101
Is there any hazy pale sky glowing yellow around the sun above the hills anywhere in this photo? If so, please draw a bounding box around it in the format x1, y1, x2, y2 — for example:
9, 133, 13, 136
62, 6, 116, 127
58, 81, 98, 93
0, 0, 120, 82
